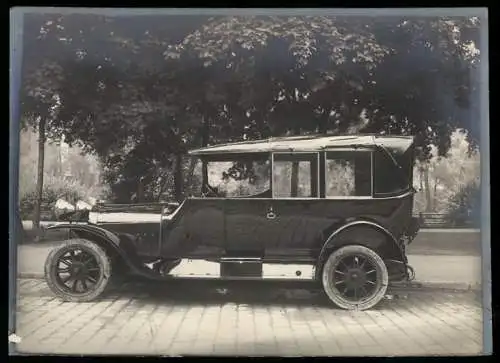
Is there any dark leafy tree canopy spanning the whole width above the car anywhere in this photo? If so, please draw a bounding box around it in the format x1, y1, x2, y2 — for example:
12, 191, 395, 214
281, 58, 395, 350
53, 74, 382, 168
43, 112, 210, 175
18, 14, 479, 201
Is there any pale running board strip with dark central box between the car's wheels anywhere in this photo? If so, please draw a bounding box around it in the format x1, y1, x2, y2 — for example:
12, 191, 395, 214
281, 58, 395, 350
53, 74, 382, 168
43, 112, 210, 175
168, 257, 315, 280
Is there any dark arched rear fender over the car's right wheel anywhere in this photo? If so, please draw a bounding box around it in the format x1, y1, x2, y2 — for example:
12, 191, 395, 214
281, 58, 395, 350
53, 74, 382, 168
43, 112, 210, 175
317, 220, 406, 278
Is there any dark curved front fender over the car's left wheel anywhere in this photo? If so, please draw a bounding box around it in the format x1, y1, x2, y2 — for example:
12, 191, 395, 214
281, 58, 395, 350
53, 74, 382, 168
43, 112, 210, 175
47, 224, 141, 273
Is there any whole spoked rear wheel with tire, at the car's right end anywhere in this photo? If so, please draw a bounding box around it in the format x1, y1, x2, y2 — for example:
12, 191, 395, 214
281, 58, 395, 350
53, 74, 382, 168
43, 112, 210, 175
322, 245, 389, 310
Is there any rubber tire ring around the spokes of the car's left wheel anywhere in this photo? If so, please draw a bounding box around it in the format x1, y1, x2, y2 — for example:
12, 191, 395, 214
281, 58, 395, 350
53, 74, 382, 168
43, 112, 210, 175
45, 238, 112, 302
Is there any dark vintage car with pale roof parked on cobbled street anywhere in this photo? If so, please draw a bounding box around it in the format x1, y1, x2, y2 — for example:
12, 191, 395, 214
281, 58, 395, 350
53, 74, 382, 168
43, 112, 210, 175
45, 135, 419, 309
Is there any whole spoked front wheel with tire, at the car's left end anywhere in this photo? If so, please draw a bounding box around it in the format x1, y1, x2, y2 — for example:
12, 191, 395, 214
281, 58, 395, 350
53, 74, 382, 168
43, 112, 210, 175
45, 238, 112, 302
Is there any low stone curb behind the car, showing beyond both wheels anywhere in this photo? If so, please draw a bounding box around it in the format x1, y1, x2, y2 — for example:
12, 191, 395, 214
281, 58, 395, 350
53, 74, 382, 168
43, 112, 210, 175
17, 272, 481, 291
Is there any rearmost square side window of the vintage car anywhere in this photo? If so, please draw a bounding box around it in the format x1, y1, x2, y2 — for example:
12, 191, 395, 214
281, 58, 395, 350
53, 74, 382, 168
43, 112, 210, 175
325, 151, 372, 198
